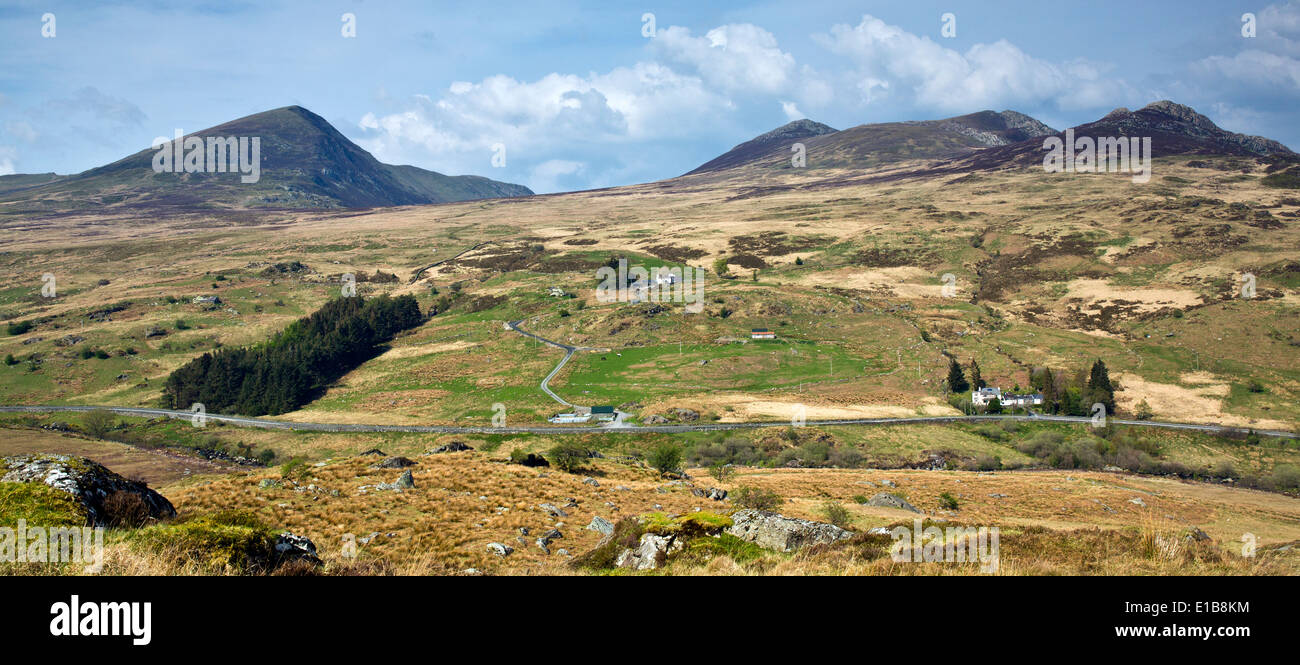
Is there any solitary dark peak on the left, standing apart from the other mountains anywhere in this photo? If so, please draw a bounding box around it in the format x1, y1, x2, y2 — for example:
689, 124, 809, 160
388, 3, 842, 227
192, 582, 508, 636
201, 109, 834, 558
0, 107, 533, 213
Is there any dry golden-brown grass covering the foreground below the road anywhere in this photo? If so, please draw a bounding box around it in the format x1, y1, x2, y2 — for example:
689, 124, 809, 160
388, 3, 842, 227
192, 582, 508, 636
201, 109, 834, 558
139, 451, 1300, 575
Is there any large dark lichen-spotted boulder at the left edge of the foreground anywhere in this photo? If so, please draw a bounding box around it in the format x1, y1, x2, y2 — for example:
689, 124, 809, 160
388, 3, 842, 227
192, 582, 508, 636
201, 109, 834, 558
0, 455, 176, 526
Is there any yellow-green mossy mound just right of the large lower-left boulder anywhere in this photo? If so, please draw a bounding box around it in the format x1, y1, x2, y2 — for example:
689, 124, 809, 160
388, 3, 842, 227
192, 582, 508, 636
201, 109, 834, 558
130, 510, 276, 573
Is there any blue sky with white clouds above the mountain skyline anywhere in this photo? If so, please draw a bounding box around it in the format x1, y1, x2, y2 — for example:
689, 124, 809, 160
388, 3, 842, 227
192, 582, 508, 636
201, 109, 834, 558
0, 0, 1300, 194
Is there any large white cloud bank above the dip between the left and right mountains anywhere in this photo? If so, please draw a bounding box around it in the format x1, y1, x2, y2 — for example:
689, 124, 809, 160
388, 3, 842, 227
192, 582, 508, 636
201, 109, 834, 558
358, 62, 736, 191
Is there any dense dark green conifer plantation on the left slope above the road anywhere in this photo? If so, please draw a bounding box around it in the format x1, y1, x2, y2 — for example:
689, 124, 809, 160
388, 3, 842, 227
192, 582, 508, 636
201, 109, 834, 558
163, 295, 423, 416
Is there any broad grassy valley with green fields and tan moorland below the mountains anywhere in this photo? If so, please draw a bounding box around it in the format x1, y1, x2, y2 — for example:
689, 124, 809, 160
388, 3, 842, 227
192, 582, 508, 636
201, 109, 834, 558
0, 98, 1300, 574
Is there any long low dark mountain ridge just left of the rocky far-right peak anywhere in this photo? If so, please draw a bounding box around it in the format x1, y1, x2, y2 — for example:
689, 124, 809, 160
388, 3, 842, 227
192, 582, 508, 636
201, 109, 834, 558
688, 110, 1056, 175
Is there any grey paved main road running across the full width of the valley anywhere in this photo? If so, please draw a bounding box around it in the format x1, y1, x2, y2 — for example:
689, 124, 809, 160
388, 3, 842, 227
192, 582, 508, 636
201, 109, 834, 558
0, 405, 1300, 439
